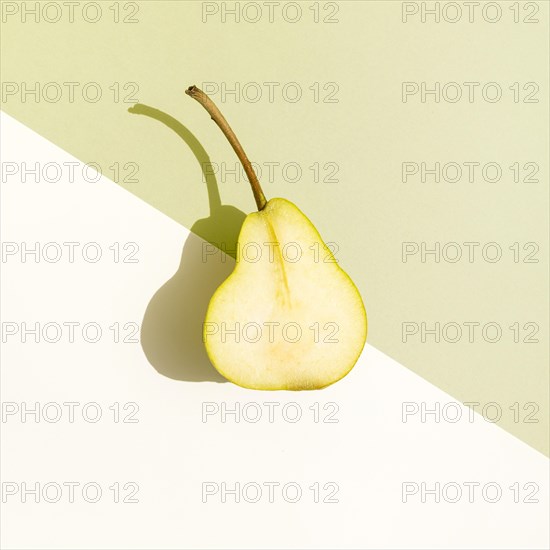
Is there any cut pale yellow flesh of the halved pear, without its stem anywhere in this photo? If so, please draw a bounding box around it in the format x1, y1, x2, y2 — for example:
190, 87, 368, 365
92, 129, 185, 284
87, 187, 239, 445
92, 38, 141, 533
203, 198, 367, 390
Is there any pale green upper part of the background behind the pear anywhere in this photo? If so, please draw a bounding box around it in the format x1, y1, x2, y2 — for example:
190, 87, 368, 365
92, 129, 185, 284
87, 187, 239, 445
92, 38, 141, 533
1, 1, 549, 453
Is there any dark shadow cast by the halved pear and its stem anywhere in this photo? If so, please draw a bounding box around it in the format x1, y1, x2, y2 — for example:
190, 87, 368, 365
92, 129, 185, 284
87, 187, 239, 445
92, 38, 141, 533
128, 103, 246, 382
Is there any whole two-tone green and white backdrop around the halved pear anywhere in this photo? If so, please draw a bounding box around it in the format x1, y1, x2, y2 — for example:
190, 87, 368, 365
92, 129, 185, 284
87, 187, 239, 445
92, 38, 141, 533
0, 0, 550, 549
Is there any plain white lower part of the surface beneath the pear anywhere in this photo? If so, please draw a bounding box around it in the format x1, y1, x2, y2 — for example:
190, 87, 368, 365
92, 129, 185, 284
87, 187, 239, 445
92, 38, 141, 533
1, 114, 548, 549
